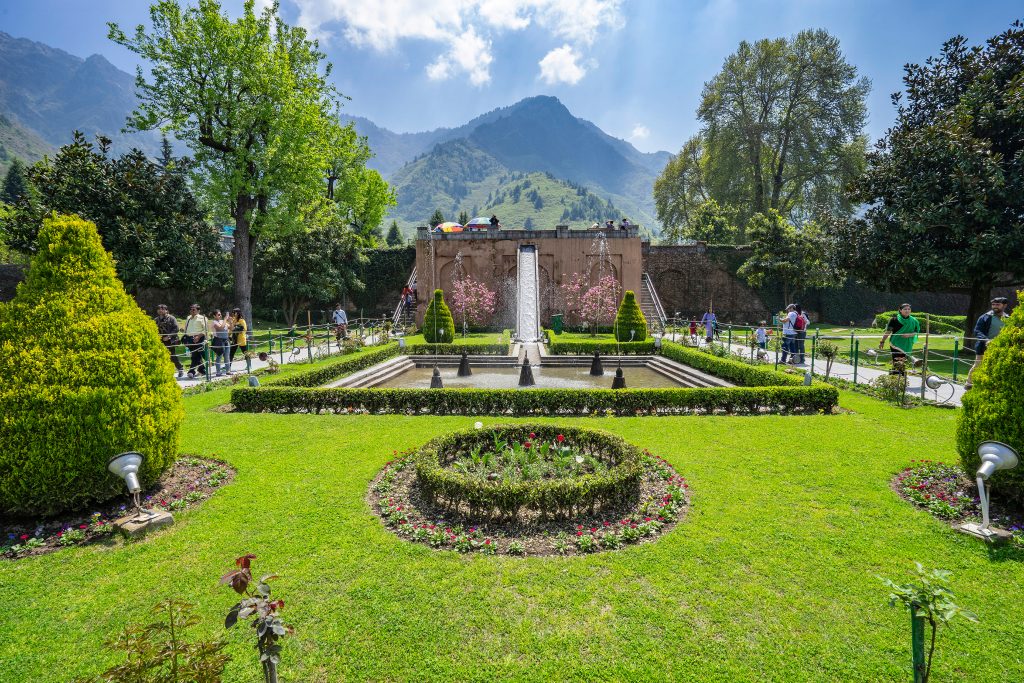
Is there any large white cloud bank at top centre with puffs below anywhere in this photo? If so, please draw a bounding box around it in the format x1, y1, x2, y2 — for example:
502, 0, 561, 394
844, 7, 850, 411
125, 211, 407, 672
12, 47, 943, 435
295, 0, 624, 85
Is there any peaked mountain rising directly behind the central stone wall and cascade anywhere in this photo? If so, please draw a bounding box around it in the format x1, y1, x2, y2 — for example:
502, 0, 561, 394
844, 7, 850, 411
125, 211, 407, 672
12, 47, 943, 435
349, 96, 671, 231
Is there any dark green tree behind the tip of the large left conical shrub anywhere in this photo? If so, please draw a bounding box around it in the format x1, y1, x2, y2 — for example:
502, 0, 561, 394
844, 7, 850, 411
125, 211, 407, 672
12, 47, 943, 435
7, 131, 229, 292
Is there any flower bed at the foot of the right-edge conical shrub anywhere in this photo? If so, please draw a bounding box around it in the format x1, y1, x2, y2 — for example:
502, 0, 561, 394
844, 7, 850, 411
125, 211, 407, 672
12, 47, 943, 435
892, 460, 1024, 548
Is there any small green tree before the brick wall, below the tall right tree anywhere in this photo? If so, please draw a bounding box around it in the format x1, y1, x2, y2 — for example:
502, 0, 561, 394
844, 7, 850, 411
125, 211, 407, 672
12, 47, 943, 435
736, 209, 840, 303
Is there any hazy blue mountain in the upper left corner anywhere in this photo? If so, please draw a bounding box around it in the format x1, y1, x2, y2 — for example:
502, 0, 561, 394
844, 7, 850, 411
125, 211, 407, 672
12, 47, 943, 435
0, 32, 160, 161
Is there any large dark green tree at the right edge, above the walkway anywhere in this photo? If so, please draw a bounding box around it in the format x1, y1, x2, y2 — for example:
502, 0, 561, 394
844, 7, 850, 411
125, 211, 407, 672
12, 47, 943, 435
827, 22, 1024, 330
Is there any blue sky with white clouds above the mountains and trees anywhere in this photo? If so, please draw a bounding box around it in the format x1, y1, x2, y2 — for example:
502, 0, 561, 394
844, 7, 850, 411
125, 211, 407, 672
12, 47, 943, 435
0, 0, 1024, 152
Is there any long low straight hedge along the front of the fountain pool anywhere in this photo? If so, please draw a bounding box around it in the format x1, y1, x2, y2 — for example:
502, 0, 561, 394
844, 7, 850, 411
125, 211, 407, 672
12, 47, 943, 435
231, 383, 839, 416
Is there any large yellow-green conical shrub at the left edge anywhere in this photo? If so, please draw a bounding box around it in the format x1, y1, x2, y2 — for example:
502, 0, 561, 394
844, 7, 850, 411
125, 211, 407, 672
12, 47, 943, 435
0, 216, 184, 515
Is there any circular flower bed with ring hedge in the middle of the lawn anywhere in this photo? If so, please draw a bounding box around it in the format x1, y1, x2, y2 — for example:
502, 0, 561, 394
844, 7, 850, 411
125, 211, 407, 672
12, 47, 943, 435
369, 423, 689, 556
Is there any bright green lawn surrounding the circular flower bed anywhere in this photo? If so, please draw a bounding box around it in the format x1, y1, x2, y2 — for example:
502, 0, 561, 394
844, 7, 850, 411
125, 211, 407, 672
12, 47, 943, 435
0, 378, 1024, 682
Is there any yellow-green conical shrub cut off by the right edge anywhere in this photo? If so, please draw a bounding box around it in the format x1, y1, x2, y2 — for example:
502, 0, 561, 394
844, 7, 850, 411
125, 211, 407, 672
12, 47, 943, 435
956, 292, 1024, 503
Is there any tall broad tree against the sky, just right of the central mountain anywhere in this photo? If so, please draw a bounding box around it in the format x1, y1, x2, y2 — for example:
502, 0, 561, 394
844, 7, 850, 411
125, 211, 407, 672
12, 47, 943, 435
655, 30, 870, 237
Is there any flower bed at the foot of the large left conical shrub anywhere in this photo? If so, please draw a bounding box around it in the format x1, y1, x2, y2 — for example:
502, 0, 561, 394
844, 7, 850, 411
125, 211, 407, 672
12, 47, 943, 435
0, 456, 234, 559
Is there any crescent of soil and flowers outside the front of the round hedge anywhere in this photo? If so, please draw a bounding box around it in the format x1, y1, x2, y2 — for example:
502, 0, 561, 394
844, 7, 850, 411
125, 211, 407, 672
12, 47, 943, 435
367, 452, 690, 557
